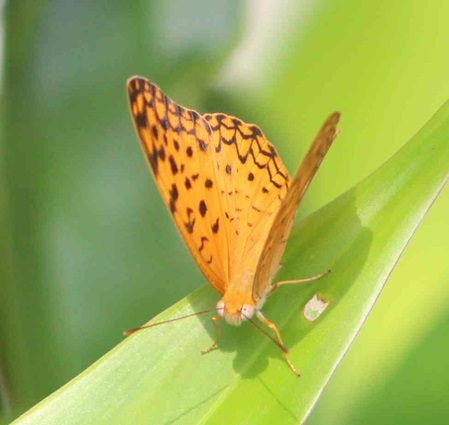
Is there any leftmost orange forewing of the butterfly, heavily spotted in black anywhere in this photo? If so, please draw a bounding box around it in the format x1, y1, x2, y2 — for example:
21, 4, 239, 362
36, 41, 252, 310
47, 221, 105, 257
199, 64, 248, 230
127, 77, 229, 293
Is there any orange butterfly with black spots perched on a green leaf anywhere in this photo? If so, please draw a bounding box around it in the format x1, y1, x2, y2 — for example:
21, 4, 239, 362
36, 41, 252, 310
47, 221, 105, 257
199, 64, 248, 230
127, 77, 340, 376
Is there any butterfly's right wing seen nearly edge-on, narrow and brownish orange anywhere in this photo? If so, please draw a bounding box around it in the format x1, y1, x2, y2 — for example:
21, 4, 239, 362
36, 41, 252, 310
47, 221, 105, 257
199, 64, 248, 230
253, 112, 340, 300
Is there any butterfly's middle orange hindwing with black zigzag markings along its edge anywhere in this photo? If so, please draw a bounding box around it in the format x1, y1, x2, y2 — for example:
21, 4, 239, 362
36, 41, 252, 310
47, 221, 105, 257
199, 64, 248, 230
200, 114, 290, 290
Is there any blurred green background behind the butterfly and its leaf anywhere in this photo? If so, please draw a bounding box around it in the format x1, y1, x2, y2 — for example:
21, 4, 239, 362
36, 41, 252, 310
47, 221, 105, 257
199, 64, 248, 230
0, 0, 449, 425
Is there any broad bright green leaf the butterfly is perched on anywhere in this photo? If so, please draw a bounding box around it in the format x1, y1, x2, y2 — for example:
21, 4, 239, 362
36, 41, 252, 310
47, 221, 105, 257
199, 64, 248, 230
11, 102, 449, 425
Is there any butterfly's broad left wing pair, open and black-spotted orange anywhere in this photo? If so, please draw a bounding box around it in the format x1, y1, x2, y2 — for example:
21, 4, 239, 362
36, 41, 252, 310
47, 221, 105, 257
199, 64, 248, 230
128, 77, 290, 296
